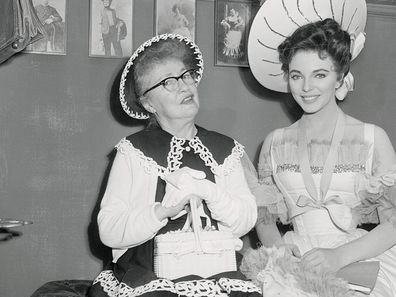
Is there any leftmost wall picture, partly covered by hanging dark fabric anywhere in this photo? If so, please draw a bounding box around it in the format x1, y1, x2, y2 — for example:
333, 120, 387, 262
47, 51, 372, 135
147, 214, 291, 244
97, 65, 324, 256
23, 0, 67, 55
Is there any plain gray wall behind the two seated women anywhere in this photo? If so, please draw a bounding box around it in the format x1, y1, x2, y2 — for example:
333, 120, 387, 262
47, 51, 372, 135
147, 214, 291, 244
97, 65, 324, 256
0, 0, 396, 297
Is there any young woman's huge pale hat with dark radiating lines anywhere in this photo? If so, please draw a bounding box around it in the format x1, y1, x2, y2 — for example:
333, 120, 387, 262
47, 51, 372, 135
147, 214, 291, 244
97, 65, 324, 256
248, 0, 367, 100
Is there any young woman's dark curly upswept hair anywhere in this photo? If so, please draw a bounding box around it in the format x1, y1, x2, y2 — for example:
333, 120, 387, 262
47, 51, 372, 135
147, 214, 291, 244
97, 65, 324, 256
278, 19, 352, 79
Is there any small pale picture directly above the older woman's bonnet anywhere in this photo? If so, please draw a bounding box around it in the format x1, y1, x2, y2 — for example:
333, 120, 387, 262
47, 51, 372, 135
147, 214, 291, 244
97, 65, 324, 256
154, 0, 196, 40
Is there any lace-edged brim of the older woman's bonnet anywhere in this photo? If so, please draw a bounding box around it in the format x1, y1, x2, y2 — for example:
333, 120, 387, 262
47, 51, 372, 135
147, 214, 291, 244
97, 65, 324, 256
119, 33, 203, 120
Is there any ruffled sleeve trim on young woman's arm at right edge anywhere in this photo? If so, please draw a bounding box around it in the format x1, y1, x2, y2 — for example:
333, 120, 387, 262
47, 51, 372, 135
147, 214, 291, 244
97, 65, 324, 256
354, 164, 396, 228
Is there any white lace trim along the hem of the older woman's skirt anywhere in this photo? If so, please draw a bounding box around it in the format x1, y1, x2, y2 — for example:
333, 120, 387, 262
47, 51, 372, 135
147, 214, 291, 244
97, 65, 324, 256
93, 270, 261, 297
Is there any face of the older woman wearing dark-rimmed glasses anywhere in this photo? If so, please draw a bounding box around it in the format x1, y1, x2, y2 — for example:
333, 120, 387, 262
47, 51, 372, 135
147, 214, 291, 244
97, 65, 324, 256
140, 59, 199, 123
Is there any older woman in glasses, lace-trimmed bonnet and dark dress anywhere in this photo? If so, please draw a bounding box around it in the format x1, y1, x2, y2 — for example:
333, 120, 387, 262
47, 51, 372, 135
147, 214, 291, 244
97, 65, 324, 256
90, 34, 259, 296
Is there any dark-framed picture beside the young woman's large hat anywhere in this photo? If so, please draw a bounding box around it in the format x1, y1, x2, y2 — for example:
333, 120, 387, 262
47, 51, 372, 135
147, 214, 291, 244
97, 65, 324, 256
215, 0, 260, 67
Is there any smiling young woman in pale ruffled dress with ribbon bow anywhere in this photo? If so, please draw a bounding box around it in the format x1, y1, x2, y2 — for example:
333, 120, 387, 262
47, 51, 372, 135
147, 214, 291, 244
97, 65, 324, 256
250, 0, 396, 296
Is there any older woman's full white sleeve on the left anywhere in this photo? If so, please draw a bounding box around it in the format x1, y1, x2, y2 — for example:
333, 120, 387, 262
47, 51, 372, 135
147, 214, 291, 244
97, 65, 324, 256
98, 151, 167, 249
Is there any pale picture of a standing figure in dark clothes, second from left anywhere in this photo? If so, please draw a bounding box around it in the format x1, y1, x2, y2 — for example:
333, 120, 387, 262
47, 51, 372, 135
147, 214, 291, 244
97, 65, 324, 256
89, 0, 133, 58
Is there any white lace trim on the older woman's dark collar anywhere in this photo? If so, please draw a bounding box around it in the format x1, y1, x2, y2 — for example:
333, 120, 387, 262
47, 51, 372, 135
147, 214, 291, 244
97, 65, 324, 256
116, 136, 245, 179
